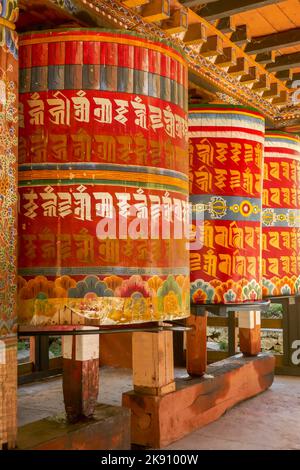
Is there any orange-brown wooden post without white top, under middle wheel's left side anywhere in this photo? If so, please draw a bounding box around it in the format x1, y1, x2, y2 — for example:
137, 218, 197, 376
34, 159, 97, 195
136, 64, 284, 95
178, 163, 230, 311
186, 310, 207, 376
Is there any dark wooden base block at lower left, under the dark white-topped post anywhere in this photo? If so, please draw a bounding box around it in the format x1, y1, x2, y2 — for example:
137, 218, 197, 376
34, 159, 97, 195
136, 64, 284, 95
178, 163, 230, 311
17, 405, 130, 450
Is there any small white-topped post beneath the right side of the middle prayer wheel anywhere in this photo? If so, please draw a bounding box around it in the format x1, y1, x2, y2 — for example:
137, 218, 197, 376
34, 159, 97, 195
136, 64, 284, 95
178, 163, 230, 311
238, 310, 261, 356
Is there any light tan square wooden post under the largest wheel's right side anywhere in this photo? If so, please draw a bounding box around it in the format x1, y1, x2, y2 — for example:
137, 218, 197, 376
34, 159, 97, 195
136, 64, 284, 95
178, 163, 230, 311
132, 331, 175, 396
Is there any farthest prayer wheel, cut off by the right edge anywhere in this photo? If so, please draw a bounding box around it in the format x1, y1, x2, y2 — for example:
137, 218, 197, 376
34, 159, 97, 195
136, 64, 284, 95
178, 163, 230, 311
262, 131, 300, 296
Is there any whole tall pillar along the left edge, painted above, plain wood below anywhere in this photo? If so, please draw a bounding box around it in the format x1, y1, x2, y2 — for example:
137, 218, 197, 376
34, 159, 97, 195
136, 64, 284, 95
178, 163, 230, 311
0, 0, 18, 450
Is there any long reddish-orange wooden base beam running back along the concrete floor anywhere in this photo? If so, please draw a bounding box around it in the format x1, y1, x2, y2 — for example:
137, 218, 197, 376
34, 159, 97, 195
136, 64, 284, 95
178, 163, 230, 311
123, 353, 275, 448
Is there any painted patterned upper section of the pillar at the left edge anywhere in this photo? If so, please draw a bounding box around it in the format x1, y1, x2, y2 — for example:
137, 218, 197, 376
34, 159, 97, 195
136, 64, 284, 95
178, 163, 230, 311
0, 13, 18, 337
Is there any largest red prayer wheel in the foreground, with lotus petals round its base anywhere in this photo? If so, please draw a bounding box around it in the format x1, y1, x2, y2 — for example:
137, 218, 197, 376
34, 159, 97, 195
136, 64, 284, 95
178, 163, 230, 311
19, 29, 189, 325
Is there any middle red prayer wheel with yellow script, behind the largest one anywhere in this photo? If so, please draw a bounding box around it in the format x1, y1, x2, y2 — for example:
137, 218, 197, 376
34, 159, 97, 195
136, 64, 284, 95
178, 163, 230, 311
189, 105, 264, 304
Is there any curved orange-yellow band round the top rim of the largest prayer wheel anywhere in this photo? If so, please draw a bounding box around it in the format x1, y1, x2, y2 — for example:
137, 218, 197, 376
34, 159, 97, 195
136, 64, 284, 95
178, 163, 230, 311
20, 34, 187, 67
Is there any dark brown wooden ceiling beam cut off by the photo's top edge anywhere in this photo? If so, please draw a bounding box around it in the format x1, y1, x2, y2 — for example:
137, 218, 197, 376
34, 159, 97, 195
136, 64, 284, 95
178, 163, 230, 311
189, 0, 282, 21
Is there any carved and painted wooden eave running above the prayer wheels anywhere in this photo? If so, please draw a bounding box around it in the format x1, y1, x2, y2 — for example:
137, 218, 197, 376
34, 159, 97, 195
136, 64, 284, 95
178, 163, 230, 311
19, 0, 300, 127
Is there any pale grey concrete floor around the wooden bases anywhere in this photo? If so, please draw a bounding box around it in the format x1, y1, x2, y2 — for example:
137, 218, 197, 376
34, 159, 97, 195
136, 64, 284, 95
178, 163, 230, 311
19, 367, 300, 450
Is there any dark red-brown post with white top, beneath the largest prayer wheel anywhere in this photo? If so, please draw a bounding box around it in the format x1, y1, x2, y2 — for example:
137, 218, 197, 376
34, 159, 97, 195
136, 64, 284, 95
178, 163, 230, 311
63, 334, 99, 422
